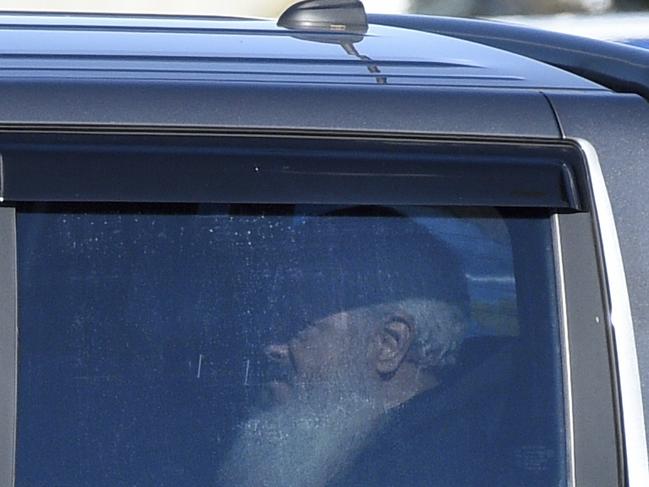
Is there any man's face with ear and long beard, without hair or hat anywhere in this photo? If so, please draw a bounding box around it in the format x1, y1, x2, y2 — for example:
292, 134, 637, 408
222, 306, 430, 487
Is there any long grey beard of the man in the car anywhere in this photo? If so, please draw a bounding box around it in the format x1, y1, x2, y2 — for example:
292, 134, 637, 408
217, 387, 383, 487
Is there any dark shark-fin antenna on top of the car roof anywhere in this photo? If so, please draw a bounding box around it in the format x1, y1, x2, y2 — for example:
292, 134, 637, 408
277, 0, 367, 36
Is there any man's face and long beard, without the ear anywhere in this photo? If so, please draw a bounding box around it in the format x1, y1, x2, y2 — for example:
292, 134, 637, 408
219, 312, 382, 487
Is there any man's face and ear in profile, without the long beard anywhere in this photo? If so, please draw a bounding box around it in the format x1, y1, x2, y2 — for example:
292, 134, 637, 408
265, 308, 423, 408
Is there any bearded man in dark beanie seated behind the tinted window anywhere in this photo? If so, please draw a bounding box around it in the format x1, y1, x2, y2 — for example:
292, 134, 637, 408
218, 209, 468, 487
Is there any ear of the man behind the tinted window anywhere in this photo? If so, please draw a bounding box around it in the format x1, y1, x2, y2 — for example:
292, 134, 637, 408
376, 318, 414, 375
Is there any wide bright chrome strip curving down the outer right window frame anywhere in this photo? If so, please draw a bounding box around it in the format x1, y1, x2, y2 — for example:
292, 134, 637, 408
572, 138, 649, 487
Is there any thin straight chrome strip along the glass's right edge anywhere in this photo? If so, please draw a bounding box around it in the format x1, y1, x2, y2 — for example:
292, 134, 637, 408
551, 213, 577, 486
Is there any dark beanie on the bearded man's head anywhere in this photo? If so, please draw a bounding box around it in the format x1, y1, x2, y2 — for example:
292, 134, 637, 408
242, 207, 468, 330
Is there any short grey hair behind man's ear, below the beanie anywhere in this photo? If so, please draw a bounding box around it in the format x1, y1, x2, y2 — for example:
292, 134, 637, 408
364, 299, 467, 370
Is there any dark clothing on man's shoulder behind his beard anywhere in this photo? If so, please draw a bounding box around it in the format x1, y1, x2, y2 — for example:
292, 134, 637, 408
328, 346, 509, 487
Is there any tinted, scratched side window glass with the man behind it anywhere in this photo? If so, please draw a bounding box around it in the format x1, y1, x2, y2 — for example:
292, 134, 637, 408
16, 205, 565, 487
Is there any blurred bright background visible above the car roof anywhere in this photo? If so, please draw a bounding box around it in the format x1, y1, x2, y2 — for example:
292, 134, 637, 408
0, 0, 649, 43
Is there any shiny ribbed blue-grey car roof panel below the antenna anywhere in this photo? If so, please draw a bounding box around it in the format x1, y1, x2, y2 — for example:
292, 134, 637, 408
0, 13, 604, 90
